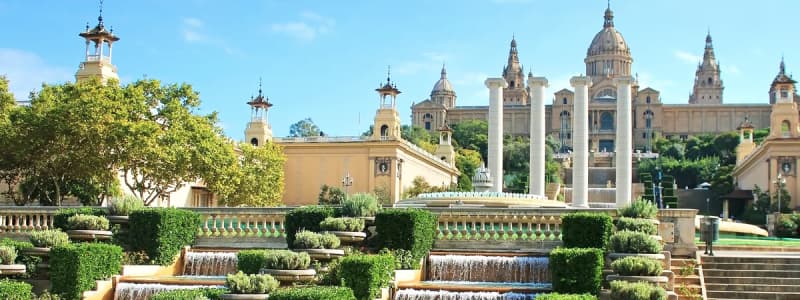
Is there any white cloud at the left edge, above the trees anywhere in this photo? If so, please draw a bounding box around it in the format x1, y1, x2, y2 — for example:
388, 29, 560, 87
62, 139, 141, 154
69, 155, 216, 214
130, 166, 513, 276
0, 48, 73, 100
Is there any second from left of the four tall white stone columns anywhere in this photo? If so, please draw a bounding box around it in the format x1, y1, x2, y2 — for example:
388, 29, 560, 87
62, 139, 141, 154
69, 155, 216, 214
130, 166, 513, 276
528, 77, 547, 195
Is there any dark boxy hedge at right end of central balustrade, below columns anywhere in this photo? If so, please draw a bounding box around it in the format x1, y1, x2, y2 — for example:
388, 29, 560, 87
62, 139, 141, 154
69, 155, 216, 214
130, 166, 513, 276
561, 212, 614, 249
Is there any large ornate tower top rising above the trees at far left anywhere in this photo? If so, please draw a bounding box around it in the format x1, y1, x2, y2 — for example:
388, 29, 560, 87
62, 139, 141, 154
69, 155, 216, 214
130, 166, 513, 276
75, 1, 119, 82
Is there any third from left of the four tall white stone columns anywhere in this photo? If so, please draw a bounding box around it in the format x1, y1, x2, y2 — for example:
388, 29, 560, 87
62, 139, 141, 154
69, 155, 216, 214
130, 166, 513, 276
569, 76, 592, 207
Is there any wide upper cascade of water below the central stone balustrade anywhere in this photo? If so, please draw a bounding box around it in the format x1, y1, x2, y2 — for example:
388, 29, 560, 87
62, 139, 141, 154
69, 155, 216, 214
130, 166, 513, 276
427, 255, 550, 284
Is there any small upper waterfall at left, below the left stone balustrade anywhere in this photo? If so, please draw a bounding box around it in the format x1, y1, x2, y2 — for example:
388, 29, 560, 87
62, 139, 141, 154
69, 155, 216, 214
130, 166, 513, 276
183, 252, 237, 276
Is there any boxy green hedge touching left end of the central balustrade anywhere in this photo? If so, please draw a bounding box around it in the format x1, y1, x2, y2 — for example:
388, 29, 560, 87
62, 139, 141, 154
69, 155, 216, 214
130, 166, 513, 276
375, 208, 437, 268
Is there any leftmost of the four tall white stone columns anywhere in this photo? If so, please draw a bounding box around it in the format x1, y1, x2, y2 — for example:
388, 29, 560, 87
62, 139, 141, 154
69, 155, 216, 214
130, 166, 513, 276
484, 78, 508, 192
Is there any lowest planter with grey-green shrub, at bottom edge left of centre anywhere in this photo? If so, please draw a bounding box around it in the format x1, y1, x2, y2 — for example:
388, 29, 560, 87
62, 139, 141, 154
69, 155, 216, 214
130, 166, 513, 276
220, 271, 280, 300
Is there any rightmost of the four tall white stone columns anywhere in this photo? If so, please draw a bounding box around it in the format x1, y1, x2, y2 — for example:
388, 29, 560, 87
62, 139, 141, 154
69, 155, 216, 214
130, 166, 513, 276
614, 77, 633, 207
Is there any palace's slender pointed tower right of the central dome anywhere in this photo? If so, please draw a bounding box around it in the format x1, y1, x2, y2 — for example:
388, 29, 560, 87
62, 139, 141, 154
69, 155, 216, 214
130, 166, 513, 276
689, 32, 724, 104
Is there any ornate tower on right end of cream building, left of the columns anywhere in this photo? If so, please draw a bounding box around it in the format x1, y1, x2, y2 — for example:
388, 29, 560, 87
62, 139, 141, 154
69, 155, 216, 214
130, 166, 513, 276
372, 72, 400, 139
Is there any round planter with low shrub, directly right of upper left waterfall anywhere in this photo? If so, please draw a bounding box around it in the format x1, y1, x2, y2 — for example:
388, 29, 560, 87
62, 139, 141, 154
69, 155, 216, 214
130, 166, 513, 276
261, 250, 317, 282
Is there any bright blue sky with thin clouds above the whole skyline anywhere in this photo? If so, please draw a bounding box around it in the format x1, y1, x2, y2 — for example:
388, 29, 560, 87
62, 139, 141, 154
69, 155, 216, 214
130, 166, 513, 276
0, 0, 800, 140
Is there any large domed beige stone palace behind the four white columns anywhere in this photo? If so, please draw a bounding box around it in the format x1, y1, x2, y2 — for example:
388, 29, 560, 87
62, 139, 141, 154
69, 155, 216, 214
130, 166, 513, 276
411, 8, 774, 152
